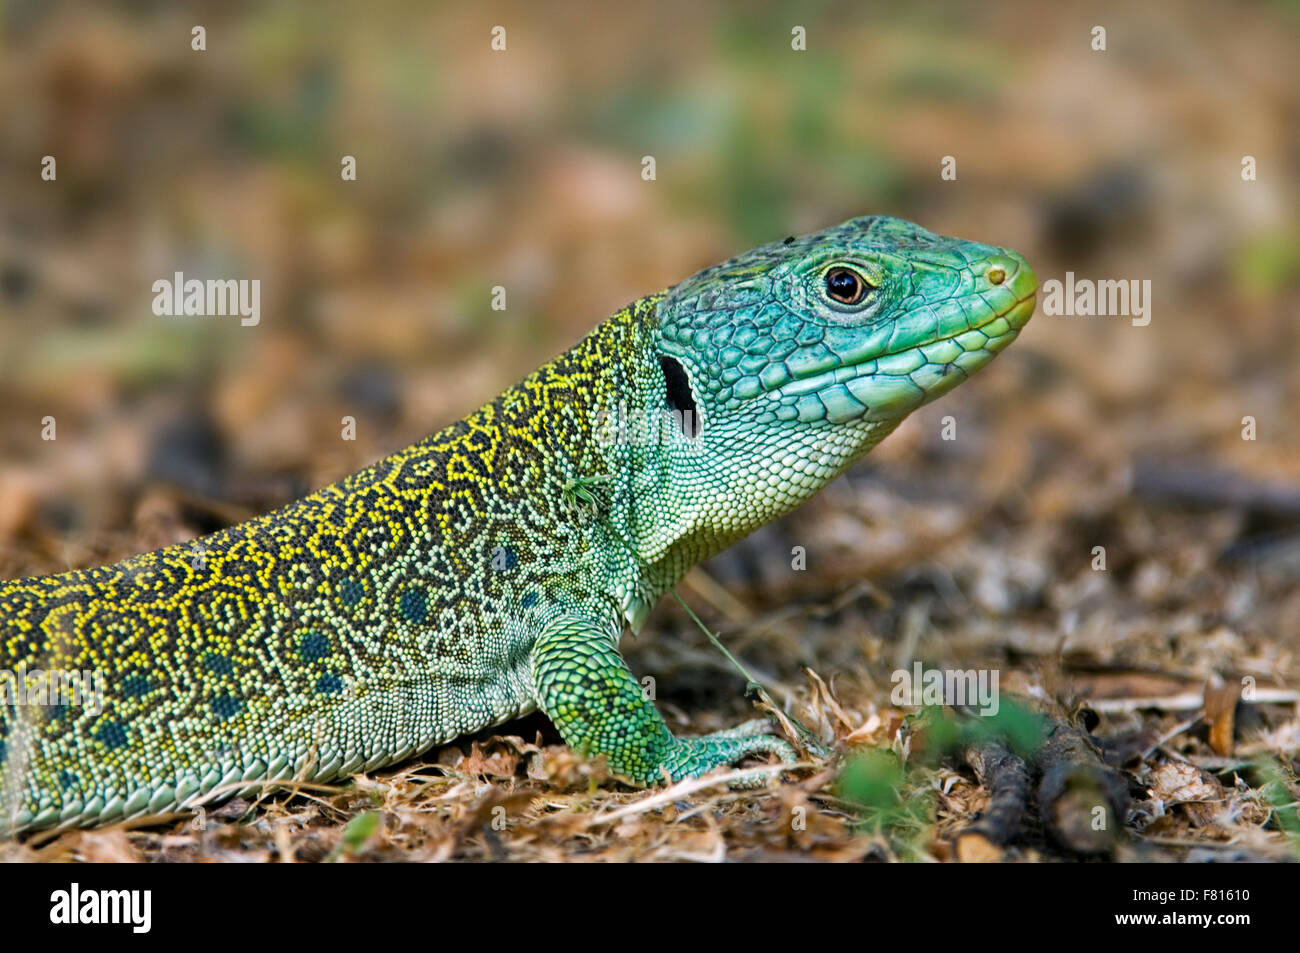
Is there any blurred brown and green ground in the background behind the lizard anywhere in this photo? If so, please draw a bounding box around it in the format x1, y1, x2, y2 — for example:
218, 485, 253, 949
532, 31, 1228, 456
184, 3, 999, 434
0, 0, 1300, 754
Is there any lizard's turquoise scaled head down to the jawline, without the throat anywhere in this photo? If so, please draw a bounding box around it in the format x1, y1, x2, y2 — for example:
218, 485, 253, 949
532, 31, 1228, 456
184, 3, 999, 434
658, 216, 1037, 439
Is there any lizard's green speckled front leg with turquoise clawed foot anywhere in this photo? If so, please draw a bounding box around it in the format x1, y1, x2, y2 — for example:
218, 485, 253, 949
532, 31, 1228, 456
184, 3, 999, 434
533, 615, 796, 787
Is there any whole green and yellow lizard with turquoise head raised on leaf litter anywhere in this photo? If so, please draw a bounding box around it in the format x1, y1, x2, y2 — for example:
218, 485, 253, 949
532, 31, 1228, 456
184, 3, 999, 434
0, 216, 1037, 836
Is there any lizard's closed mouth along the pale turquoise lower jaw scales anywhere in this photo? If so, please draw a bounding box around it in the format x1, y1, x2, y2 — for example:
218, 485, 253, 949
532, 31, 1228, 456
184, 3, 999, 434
768, 260, 1039, 424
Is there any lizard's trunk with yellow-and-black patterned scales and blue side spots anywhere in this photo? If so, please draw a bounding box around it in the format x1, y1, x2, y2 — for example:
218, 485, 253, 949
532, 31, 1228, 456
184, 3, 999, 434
0, 299, 655, 829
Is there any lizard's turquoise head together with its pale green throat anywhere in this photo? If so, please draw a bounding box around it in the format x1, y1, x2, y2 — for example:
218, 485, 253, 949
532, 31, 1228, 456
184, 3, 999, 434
611, 217, 1037, 579
